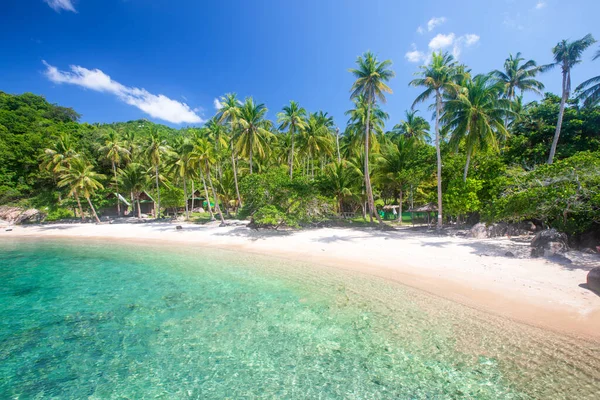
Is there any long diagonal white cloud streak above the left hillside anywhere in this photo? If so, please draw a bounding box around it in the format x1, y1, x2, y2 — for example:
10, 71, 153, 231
43, 61, 203, 124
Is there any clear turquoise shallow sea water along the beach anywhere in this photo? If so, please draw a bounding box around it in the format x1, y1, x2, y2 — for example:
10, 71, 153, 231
0, 240, 600, 399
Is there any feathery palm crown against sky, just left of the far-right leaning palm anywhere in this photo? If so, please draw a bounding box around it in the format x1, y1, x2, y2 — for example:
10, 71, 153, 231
492, 53, 544, 101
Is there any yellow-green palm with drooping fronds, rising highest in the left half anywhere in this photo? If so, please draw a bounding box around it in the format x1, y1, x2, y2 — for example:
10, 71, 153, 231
236, 97, 272, 174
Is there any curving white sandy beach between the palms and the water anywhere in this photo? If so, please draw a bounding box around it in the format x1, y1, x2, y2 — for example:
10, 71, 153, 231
0, 223, 600, 340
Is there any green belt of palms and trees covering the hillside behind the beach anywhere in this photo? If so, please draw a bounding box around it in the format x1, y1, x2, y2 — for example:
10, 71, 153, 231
0, 35, 600, 241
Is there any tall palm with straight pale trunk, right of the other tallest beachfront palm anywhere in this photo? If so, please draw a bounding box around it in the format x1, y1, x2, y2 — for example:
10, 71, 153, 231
409, 52, 458, 230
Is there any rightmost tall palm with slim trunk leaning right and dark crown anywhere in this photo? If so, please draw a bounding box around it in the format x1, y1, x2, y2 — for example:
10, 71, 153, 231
542, 34, 596, 164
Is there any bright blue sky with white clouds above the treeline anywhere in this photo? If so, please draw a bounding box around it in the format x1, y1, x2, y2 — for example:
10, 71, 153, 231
0, 0, 600, 127
